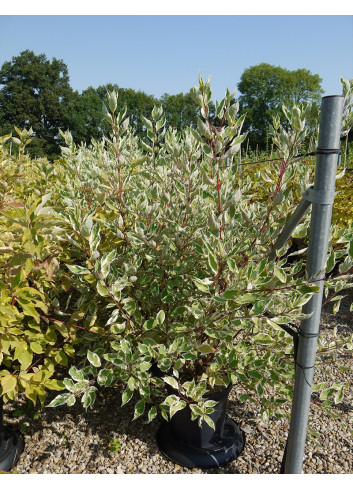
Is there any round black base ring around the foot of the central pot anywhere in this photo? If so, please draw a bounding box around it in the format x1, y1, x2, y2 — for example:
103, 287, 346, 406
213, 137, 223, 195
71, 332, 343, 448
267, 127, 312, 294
157, 418, 245, 468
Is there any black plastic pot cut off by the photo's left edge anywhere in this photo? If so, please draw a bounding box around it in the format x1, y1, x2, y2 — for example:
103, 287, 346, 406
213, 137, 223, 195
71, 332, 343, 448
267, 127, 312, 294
0, 398, 24, 472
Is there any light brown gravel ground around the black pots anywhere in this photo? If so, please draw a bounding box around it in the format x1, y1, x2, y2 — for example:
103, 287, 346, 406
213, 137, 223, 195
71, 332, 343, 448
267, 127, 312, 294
4, 298, 353, 474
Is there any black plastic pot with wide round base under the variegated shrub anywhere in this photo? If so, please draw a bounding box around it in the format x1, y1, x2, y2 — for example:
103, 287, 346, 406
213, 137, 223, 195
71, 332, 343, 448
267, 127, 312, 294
157, 385, 245, 468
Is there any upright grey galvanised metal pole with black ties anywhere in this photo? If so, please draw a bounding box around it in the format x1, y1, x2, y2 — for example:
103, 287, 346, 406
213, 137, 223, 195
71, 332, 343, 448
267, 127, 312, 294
284, 95, 344, 474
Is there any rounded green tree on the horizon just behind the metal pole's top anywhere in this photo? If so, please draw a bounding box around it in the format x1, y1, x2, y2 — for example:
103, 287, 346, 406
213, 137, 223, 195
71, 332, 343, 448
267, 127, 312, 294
238, 63, 323, 148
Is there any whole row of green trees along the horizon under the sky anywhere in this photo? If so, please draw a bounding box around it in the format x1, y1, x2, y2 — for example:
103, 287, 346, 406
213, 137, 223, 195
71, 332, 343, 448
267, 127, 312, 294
0, 50, 323, 159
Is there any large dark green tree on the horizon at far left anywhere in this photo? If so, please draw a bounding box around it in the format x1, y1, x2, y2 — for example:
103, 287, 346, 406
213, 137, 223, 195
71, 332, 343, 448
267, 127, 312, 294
0, 50, 78, 157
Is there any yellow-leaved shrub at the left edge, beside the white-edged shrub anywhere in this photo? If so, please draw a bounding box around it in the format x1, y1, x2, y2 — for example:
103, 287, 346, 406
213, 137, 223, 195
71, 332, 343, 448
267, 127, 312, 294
0, 135, 76, 404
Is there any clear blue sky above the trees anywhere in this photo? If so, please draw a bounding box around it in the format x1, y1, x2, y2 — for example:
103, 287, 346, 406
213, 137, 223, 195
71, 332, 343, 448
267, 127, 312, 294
0, 0, 353, 100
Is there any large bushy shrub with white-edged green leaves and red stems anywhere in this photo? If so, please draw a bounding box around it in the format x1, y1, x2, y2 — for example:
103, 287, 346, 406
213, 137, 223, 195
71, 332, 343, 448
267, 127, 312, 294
48, 77, 353, 426
